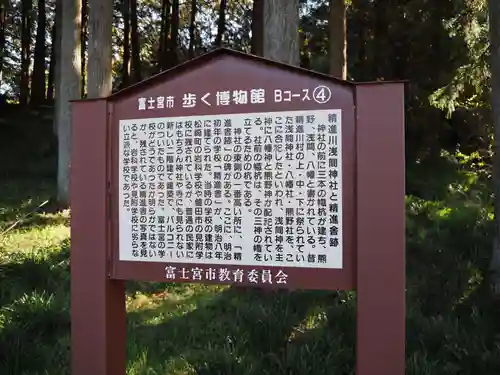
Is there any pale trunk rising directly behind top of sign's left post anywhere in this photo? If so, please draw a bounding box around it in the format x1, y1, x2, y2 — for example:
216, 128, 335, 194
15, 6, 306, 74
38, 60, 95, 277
87, 0, 113, 98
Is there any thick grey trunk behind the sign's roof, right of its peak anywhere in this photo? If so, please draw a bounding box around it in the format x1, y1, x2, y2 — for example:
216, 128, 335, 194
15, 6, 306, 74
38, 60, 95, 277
263, 0, 300, 66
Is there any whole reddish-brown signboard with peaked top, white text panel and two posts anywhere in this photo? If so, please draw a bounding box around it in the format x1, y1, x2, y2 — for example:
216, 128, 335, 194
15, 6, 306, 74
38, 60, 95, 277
71, 49, 405, 375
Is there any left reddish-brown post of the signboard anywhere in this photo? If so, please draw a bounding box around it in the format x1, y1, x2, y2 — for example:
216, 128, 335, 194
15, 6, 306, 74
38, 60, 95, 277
70, 100, 126, 375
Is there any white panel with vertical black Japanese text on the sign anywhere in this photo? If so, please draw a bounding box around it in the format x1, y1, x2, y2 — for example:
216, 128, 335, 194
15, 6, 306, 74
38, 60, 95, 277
118, 110, 342, 268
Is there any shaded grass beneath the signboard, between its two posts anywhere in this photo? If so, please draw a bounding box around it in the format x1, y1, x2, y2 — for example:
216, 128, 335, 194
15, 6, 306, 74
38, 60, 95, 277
129, 288, 354, 375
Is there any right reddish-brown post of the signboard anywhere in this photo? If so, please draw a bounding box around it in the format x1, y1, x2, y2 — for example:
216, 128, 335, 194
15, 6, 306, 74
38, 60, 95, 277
356, 83, 405, 375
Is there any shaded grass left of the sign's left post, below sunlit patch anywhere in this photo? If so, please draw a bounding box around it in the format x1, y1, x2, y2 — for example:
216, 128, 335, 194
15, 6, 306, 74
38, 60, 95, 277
0, 241, 69, 375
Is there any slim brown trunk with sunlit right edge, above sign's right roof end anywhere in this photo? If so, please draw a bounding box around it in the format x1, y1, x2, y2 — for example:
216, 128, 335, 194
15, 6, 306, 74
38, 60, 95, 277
328, 0, 347, 79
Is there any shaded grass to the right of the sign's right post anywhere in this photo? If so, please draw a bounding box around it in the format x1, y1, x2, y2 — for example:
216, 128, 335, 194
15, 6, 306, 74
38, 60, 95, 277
406, 194, 500, 375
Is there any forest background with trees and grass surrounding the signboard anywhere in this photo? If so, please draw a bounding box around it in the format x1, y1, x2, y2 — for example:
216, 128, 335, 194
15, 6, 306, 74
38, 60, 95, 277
0, 0, 500, 375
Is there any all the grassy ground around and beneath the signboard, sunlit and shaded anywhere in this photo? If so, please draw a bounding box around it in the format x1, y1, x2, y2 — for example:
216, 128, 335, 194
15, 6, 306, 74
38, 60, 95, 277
0, 146, 500, 375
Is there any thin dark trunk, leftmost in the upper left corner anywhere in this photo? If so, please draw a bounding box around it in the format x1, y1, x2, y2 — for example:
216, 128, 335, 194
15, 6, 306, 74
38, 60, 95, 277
19, 0, 33, 105
